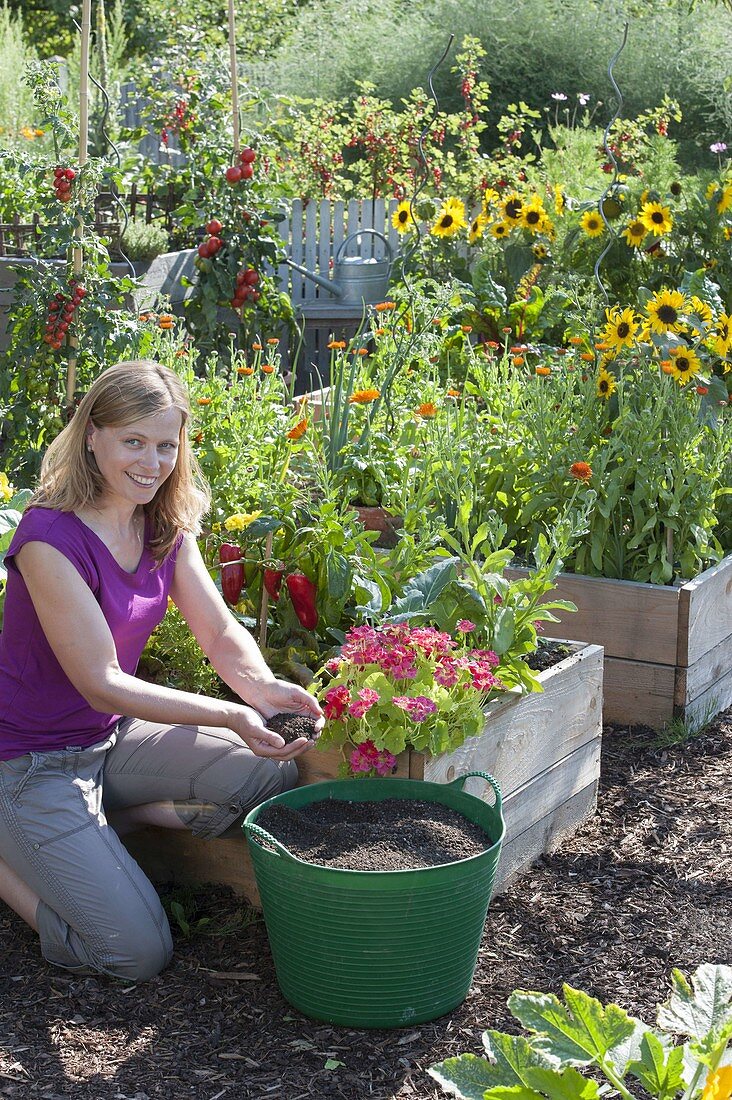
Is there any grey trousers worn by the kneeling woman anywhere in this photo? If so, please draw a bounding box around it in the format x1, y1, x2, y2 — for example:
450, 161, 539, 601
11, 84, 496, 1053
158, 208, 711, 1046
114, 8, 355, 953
0, 718, 297, 981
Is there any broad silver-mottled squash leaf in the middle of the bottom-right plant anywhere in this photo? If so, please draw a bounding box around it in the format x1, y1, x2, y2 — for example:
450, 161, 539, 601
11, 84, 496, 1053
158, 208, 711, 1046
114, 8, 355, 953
509, 986, 635, 1066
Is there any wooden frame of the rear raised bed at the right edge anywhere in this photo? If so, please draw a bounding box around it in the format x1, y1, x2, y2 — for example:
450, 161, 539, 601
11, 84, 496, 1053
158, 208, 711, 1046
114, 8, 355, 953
506, 554, 732, 728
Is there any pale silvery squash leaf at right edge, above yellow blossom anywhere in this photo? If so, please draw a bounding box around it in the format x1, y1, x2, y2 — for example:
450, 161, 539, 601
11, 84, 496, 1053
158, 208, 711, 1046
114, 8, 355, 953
658, 963, 732, 1041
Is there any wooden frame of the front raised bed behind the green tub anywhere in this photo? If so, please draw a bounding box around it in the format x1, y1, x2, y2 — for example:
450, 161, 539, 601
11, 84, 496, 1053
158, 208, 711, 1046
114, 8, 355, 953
124, 644, 602, 904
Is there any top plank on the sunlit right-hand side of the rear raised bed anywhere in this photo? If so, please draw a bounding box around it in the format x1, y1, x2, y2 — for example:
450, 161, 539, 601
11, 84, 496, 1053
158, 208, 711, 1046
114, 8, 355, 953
676, 554, 732, 667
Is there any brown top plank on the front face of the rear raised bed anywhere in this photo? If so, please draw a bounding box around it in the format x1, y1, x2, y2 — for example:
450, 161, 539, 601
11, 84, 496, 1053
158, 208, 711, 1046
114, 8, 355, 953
505, 567, 678, 666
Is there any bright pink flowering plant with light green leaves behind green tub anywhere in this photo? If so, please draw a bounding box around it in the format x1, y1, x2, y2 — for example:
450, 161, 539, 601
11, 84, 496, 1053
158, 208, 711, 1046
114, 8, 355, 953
319, 619, 503, 776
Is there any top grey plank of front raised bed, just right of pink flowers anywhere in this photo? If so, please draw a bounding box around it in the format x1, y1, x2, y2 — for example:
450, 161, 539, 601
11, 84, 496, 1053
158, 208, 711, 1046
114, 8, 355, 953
420, 646, 602, 796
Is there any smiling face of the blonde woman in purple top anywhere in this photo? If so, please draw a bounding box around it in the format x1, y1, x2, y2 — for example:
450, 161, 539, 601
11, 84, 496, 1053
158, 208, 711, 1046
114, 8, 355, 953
87, 406, 183, 506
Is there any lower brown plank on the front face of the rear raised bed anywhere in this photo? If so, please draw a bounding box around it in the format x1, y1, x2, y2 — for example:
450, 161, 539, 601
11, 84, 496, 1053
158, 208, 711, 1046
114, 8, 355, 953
603, 657, 676, 727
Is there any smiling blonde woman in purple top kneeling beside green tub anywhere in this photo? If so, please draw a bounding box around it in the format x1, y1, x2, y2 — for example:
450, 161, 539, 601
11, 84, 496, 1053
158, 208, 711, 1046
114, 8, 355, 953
0, 361, 323, 980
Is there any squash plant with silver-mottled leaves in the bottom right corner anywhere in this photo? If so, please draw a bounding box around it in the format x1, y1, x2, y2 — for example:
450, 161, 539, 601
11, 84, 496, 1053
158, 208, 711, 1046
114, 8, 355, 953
428, 964, 732, 1100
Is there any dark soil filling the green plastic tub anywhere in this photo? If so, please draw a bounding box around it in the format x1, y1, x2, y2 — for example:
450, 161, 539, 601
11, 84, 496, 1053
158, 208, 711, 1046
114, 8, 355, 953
256, 796, 493, 871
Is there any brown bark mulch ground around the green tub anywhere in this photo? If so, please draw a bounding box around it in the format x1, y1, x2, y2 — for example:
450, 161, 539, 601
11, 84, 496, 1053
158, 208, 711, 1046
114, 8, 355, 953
0, 711, 732, 1100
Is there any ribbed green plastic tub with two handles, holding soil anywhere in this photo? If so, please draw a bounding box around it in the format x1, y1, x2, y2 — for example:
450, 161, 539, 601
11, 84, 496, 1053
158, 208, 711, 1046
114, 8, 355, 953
242, 772, 505, 1027
